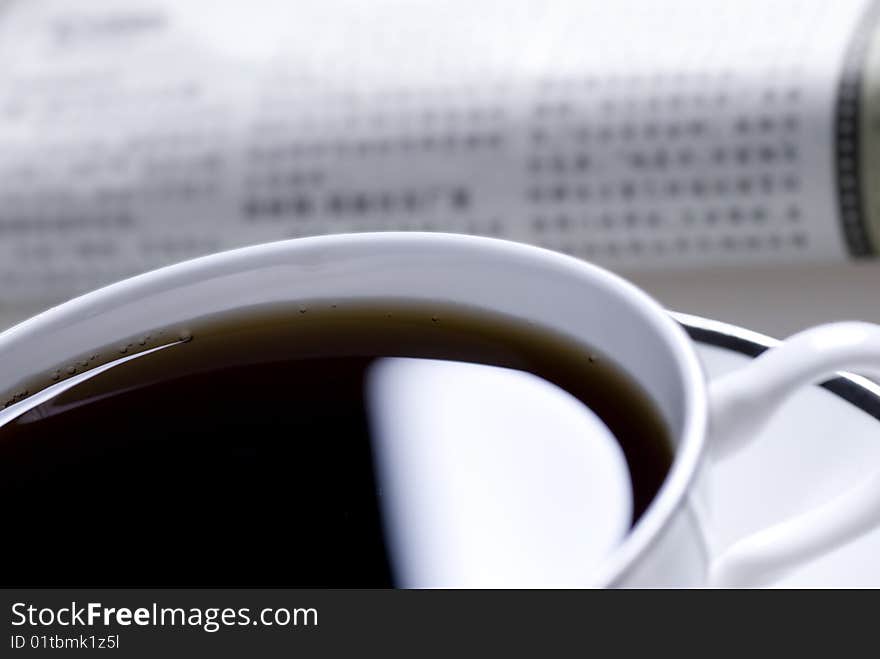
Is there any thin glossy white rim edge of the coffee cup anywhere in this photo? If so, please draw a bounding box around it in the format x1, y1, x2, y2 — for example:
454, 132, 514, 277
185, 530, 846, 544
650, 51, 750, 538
0, 232, 708, 586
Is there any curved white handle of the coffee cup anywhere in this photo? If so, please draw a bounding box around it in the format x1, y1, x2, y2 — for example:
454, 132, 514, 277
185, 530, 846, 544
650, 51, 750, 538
709, 322, 880, 587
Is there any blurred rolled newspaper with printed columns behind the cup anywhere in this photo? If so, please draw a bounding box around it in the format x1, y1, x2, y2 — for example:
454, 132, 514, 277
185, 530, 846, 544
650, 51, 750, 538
0, 0, 880, 315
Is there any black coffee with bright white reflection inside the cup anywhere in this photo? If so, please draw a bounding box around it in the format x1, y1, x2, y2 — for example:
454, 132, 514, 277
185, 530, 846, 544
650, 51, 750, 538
0, 302, 671, 587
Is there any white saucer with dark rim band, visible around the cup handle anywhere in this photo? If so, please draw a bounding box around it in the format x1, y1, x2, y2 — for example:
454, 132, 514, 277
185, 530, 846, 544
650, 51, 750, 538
676, 314, 880, 588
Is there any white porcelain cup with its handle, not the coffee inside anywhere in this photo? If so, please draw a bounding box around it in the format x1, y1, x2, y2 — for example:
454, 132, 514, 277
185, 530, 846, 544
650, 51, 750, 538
0, 233, 880, 587
